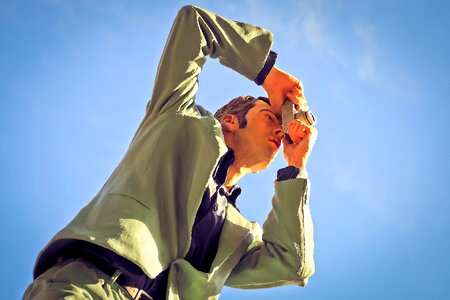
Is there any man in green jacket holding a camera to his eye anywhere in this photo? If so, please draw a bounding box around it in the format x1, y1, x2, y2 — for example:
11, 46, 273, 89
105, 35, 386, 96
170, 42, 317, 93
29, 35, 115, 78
24, 6, 317, 299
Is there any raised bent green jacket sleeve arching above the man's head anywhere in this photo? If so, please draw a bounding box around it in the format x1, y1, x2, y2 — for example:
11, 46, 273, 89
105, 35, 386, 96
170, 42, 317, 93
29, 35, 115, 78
147, 6, 273, 114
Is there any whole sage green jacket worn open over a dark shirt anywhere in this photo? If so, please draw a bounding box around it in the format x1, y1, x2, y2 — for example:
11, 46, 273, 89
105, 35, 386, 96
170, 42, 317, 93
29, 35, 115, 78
35, 6, 314, 299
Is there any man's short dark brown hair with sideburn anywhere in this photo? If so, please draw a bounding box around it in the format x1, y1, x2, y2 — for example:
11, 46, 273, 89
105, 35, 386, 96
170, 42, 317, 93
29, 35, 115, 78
214, 96, 270, 128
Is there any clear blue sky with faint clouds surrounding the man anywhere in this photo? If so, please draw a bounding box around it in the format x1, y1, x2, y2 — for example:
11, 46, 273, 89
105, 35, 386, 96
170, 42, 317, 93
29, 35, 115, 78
0, 0, 450, 299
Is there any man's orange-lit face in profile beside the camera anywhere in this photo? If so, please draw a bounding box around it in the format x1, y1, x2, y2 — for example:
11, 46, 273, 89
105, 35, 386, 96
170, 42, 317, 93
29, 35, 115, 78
234, 100, 284, 172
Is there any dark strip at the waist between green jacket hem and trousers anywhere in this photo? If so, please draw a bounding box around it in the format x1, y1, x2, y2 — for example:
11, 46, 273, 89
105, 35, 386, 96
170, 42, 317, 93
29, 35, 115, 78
60, 242, 153, 300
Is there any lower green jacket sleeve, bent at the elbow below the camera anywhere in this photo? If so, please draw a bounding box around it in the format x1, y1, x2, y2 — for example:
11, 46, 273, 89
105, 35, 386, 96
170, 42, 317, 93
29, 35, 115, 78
226, 178, 314, 288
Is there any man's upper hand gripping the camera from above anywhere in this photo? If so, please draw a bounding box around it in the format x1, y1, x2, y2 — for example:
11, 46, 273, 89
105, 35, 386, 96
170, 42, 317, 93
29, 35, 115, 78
262, 66, 308, 115
